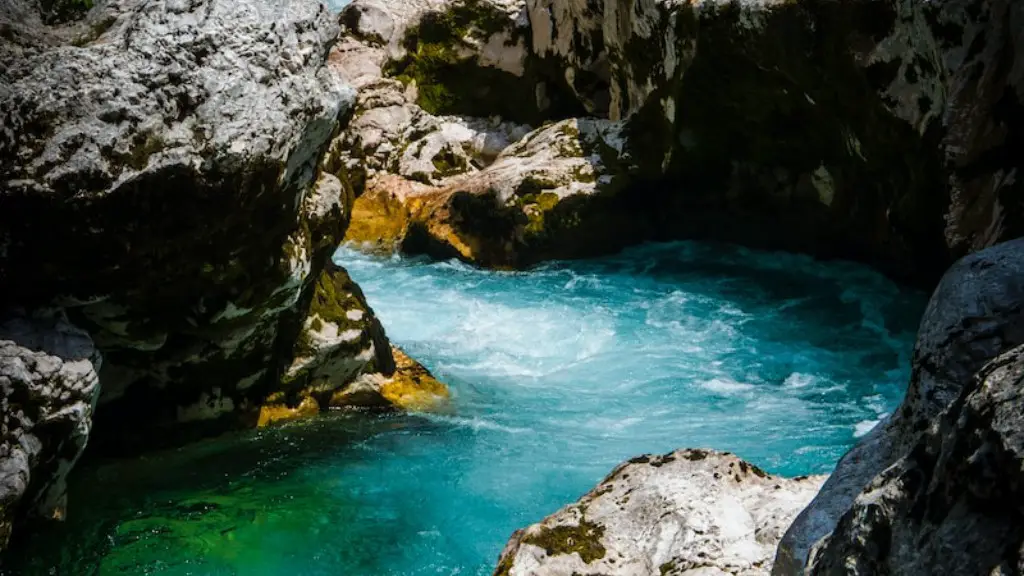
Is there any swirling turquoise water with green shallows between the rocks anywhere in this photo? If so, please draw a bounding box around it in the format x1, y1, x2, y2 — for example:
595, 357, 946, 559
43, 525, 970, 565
2, 243, 925, 576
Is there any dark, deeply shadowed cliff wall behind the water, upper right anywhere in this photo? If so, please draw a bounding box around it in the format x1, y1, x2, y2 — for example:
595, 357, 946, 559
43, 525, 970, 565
527, 0, 1024, 278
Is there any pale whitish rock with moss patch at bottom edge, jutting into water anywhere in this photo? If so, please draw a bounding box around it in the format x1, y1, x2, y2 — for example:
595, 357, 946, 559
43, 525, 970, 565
495, 450, 824, 576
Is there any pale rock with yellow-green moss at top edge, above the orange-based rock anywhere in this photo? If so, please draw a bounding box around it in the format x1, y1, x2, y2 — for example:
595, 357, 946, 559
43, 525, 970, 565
356, 0, 579, 125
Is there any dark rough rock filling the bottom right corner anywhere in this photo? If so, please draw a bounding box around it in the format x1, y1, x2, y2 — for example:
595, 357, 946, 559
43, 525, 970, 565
808, 340, 1024, 576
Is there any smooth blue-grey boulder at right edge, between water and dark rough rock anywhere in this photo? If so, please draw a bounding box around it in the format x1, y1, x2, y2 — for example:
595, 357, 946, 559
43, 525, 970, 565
775, 239, 1024, 574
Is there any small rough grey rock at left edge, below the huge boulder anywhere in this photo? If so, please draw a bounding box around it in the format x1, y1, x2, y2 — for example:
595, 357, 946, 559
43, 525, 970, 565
0, 315, 99, 548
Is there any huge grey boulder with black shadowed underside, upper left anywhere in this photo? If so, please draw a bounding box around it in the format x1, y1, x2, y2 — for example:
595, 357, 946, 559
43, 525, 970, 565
0, 0, 399, 452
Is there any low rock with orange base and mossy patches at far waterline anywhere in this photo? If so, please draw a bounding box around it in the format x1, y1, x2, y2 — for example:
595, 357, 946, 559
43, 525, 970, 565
346, 119, 645, 268
